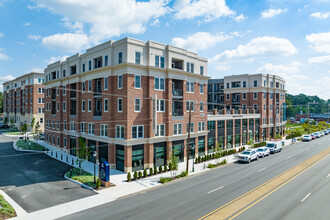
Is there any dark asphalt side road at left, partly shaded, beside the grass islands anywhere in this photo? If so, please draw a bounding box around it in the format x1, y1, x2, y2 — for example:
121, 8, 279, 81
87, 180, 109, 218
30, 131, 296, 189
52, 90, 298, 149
0, 134, 95, 212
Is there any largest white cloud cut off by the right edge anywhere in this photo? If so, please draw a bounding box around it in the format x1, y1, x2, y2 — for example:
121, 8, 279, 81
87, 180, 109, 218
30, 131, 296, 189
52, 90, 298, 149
306, 32, 330, 53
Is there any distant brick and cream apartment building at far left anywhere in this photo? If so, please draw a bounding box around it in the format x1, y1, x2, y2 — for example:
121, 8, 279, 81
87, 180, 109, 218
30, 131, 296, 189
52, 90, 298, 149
3, 72, 44, 130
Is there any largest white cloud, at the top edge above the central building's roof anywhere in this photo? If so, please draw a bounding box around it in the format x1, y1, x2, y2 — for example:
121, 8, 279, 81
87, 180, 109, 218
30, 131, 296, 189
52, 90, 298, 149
30, 0, 169, 52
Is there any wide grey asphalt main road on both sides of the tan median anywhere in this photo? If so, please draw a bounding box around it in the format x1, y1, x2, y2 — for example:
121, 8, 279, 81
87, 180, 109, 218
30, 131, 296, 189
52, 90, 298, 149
61, 135, 330, 220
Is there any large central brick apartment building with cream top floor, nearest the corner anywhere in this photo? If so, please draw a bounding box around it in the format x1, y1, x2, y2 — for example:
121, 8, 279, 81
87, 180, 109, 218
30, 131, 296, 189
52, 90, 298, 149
44, 38, 209, 172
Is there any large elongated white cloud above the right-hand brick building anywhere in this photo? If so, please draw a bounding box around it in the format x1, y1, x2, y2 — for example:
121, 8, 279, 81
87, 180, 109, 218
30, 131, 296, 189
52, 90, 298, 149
210, 36, 297, 62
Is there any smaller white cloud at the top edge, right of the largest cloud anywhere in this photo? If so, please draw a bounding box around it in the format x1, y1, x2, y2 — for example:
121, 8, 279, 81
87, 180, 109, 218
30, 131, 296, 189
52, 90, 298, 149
174, 0, 236, 22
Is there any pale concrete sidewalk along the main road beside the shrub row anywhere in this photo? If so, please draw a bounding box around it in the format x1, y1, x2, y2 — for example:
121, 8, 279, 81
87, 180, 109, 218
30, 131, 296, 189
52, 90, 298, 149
9, 140, 291, 220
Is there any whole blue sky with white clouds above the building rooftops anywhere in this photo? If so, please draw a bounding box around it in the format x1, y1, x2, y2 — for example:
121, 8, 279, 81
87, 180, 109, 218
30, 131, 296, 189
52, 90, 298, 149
0, 0, 330, 99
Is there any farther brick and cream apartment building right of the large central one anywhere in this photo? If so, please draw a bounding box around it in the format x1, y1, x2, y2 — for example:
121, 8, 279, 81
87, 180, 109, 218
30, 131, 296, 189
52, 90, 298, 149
208, 74, 286, 140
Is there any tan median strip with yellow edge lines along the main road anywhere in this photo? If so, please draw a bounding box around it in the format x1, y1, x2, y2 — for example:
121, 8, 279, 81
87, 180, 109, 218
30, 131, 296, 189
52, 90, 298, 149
200, 148, 330, 219
